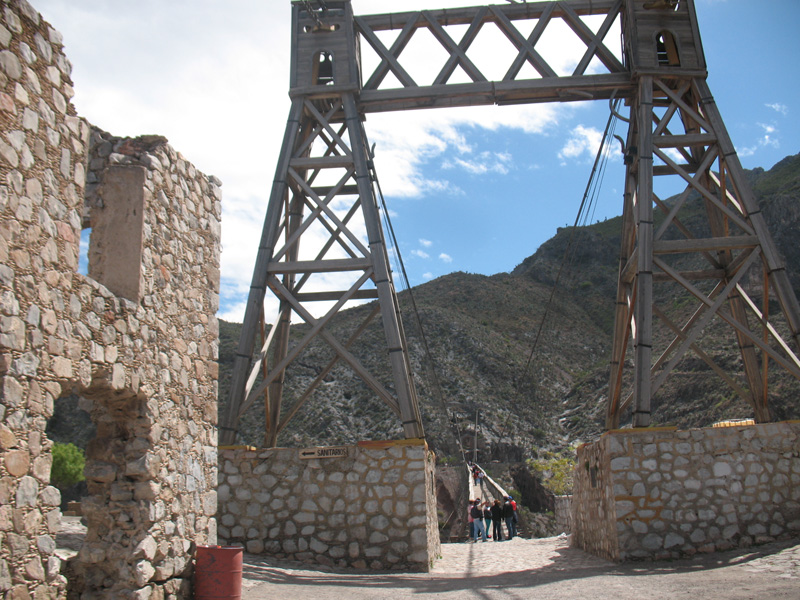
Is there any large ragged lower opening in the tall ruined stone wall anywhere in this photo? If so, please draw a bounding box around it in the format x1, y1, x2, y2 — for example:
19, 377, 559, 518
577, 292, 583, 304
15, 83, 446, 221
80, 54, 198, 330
46, 377, 152, 598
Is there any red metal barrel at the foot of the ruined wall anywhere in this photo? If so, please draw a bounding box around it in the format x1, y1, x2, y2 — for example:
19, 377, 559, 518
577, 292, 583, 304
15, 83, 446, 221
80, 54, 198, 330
194, 546, 243, 600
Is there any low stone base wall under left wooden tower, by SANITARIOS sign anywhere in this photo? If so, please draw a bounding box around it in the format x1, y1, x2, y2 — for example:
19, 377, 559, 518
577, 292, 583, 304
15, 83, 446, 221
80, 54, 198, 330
217, 441, 440, 571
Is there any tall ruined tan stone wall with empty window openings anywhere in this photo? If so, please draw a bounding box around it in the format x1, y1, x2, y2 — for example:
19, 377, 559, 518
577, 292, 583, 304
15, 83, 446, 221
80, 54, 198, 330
0, 0, 221, 600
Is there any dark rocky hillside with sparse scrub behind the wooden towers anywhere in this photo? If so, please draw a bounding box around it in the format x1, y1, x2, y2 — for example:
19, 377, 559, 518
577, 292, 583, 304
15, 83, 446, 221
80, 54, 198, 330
220, 155, 800, 461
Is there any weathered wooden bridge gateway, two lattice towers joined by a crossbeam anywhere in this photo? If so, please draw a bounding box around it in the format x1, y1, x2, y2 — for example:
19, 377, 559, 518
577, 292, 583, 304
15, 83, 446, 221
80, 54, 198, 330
220, 0, 800, 446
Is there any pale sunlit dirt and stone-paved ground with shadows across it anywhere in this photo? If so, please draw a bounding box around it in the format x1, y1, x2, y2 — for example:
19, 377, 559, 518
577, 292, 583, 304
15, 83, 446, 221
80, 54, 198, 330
242, 538, 800, 600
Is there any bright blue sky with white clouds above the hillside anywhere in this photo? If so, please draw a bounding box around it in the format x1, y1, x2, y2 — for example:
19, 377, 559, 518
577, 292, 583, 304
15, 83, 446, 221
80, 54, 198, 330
32, 0, 800, 320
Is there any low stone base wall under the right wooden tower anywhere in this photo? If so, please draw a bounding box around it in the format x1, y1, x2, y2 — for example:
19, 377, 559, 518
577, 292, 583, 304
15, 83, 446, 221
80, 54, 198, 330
572, 421, 800, 561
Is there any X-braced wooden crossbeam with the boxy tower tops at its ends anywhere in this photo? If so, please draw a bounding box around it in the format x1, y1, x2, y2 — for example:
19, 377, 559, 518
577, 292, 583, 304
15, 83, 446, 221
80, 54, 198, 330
291, 0, 706, 112
